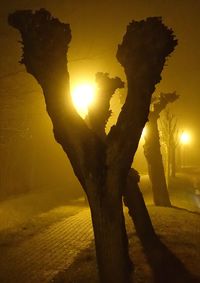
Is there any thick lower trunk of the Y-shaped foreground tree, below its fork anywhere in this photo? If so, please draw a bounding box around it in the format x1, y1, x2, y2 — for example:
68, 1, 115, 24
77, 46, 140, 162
88, 179, 131, 283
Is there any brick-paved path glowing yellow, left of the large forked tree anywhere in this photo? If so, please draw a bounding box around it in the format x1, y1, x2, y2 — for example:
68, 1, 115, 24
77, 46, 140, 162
0, 209, 93, 283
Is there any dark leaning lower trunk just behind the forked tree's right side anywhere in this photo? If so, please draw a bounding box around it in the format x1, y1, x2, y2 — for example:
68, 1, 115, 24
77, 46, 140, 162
124, 169, 158, 249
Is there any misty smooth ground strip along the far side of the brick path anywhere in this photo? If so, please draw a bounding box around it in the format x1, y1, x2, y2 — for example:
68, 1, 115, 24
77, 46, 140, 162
0, 191, 84, 232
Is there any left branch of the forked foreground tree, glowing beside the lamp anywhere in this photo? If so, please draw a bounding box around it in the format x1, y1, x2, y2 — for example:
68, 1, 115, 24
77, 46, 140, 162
8, 9, 104, 187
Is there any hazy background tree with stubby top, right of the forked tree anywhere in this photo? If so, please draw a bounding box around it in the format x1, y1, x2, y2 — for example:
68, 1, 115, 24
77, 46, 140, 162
144, 92, 178, 206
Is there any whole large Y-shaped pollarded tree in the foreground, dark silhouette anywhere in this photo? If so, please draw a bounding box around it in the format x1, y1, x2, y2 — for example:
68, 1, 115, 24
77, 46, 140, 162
9, 9, 176, 283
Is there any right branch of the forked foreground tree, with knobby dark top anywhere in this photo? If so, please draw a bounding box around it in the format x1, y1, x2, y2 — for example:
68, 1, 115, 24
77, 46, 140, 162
108, 17, 177, 174
